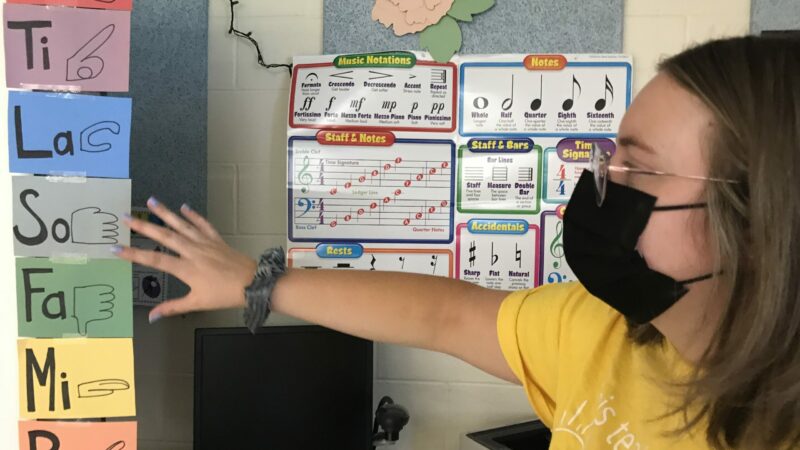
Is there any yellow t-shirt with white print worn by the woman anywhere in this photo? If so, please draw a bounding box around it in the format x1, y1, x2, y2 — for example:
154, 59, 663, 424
497, 283, 709, 450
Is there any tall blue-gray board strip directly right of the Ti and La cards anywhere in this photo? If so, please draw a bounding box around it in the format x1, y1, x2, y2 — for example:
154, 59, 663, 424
130, 0, 208, 213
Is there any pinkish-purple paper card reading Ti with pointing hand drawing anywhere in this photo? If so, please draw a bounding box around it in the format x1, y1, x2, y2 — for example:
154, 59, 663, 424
3, 3, 131, 92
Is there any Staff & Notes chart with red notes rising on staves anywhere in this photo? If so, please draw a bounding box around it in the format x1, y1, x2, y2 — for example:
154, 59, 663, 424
289, 138, 454, 242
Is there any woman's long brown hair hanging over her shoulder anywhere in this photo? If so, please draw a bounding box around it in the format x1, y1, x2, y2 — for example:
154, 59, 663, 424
630, 36, 800, 449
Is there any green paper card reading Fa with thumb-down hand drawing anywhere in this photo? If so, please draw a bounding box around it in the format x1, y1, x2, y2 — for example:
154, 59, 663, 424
16, 258, 133, 338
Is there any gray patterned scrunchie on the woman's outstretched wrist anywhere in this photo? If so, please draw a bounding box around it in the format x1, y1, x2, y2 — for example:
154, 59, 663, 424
244, 247, 286, 334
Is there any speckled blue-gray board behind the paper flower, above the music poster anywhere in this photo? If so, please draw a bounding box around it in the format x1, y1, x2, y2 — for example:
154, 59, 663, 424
323, 0, 624, 54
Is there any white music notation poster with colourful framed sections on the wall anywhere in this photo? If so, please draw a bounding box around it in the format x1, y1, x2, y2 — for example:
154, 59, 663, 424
287, 52, 632, 290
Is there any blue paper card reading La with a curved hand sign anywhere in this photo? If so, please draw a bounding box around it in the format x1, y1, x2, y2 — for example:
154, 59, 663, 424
8, 91, 132, 178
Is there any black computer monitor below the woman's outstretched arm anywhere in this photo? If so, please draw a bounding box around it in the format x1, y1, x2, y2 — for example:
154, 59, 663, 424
194, 326, 373, 450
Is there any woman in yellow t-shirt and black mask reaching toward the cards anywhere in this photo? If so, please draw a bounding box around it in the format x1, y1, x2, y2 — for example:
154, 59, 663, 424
113, 37, 800, 450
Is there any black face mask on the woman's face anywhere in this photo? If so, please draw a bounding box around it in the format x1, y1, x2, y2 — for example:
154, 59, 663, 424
564, 170, 713, 324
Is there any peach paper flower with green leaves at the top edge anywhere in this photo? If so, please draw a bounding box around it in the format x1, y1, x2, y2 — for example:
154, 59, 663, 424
372, 0, 495, 62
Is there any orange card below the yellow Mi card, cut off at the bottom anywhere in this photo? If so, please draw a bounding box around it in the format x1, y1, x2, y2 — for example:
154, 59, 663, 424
19, 421, 136, 450
